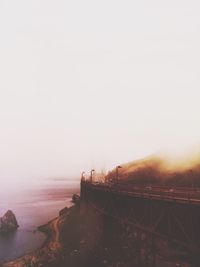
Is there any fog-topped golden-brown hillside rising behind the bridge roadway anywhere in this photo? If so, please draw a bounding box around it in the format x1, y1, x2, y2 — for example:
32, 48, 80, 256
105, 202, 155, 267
106, 153, 200, 187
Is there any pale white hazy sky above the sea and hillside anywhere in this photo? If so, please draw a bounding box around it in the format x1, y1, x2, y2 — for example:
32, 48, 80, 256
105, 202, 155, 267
0, 0, 200, 184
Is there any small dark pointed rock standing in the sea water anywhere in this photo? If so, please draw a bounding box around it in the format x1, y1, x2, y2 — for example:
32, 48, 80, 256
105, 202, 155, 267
0, 210, 19, 233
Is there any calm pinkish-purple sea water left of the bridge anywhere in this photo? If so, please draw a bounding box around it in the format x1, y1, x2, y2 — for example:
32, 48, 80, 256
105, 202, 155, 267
0, 180, 79, 262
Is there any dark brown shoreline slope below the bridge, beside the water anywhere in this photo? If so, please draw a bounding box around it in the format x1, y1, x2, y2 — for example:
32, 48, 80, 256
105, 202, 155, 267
0, 201, 191, 267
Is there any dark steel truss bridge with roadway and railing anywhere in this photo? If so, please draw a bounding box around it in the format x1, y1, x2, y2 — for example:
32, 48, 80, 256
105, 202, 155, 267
81, 180, 200, 267
